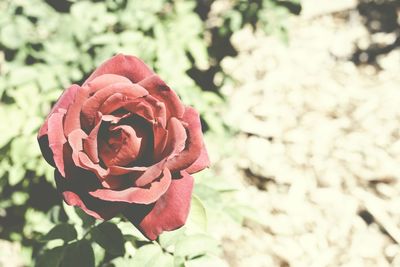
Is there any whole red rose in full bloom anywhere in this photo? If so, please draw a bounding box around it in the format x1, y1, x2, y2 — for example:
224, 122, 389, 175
38, 55, 209, 240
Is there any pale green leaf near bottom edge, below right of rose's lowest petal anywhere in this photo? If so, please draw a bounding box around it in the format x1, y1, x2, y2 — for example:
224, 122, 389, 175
174, 234, 220, 258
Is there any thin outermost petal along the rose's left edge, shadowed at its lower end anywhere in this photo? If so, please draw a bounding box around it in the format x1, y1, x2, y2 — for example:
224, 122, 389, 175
38, 84, 79, 166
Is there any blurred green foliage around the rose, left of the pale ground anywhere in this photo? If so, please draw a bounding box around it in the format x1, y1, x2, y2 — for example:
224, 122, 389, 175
0, 0, 298, 267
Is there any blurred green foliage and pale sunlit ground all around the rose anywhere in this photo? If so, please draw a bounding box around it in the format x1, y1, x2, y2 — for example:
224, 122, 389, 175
0, 0, 400, 267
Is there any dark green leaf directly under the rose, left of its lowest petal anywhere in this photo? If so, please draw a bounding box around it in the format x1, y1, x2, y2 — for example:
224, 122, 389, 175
91, 222, 125, 256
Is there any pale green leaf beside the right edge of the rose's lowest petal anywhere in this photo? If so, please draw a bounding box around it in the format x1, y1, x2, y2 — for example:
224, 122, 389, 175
186, 195, 207, 232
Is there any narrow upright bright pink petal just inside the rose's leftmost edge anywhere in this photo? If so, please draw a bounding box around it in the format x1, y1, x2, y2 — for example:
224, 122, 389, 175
47, 113, 67, 177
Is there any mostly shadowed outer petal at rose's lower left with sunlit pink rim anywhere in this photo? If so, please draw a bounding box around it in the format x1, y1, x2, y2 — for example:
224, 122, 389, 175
54, 170, 126, 220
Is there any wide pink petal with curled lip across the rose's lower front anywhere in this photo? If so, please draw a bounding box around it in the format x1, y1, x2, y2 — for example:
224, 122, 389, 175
89, 169, 171, 204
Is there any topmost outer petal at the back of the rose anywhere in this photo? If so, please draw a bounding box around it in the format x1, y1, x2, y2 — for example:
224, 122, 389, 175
84, 54, 153, 85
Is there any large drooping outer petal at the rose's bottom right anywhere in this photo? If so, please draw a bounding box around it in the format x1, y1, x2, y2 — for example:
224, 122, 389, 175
124, 172, 193, 240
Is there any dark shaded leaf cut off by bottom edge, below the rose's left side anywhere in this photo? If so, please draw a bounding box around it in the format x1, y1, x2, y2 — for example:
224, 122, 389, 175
61, 239, 95, 267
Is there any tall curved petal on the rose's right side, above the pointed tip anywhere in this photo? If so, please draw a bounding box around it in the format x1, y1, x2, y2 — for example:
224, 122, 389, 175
167, 107, 203, 172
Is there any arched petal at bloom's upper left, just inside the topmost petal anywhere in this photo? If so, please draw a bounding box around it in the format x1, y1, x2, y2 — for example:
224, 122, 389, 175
81, 83, 148, 130
